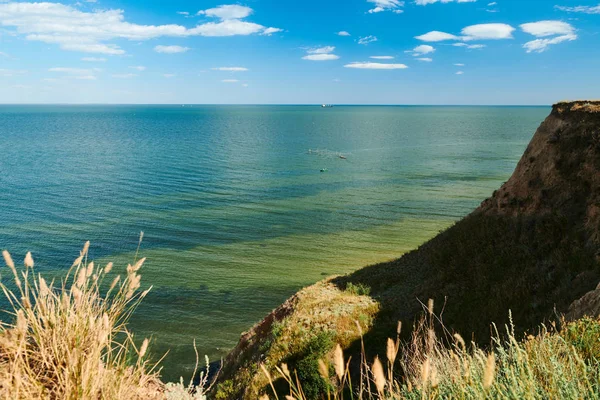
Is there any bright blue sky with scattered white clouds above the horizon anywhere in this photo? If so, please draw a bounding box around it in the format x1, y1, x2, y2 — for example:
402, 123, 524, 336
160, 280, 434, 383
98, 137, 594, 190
0, 0, 600, 105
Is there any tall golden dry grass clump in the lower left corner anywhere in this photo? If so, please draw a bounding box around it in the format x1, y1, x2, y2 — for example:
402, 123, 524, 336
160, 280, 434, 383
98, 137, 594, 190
0, 242, 209, 400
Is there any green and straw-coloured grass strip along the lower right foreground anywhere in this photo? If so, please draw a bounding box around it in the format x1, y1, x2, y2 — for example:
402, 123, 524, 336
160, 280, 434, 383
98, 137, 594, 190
263, 302, 600, 400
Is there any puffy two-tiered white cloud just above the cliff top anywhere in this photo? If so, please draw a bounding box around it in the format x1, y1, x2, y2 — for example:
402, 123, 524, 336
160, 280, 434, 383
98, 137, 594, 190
521, 21, 577, 53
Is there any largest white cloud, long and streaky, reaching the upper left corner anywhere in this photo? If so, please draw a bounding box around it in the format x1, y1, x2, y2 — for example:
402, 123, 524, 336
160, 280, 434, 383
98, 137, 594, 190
0, 0, 279, 55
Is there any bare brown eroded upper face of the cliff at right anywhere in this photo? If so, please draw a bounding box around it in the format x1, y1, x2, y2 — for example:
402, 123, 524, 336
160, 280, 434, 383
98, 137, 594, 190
479, 101, 600, 245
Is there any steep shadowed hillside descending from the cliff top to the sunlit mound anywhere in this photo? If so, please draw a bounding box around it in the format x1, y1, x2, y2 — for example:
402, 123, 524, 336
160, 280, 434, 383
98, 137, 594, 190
216, 101, 600, 398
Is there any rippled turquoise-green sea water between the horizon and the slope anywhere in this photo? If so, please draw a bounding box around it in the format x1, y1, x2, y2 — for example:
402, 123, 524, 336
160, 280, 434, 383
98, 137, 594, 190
0, 106, 549, 379
